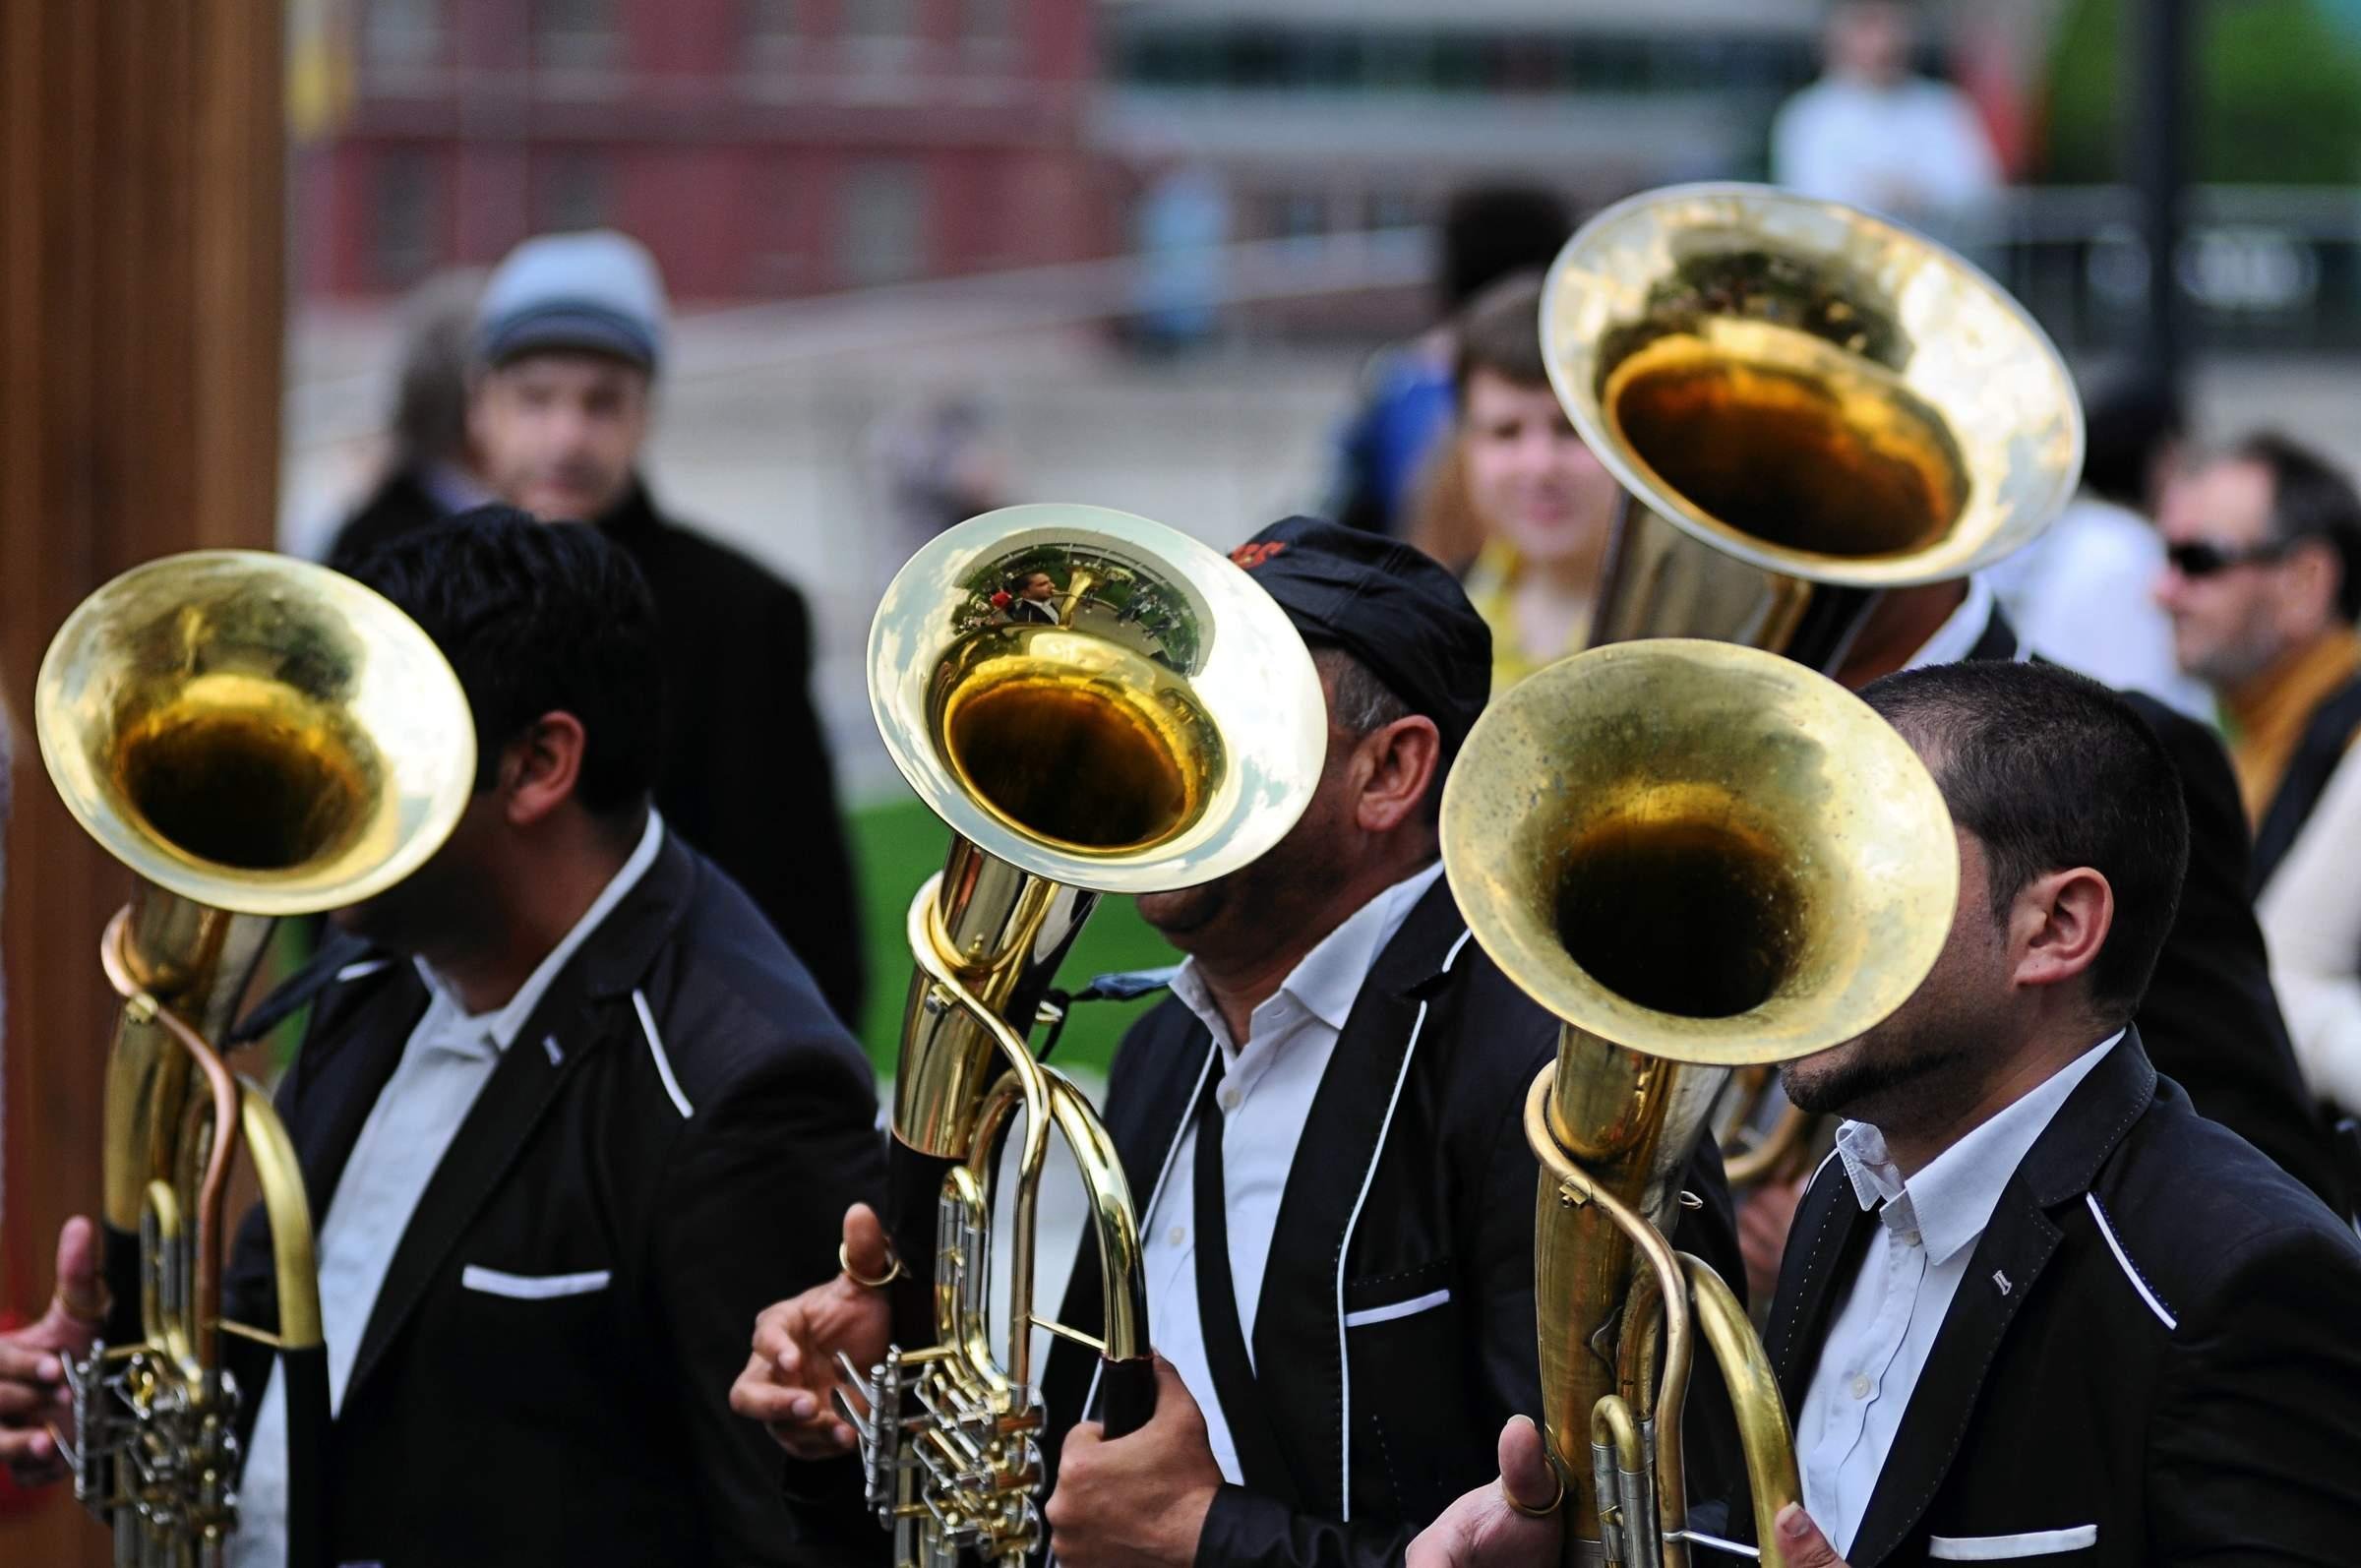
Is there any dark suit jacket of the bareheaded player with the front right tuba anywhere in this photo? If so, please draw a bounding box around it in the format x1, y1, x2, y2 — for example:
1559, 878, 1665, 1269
1769, 1030, 2361, 1568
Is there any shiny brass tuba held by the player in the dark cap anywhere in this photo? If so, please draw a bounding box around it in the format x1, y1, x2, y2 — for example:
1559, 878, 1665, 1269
843, 506, 1327, 1568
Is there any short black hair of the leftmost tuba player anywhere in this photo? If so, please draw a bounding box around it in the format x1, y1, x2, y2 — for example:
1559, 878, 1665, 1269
352, 506, 663, 819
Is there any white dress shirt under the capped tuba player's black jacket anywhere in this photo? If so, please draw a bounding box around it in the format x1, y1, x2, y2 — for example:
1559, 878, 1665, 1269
1147, 862, 1442, 1483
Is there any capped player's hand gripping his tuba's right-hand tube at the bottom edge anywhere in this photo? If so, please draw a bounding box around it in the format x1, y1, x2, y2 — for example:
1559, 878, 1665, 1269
1044, 1356, 1221, 1568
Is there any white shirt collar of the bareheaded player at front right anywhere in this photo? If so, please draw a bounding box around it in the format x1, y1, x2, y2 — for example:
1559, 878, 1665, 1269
1837, 1030, 2125, 1263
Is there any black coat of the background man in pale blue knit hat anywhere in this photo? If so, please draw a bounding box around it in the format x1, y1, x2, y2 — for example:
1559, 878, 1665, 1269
600, 484, 869, 1027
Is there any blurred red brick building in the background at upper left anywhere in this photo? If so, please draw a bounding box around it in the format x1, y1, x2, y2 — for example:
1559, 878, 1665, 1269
295, 0, 1110, 300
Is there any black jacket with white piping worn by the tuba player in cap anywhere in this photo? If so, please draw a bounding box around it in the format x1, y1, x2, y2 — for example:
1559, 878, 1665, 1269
1024, 880, 1745, 1568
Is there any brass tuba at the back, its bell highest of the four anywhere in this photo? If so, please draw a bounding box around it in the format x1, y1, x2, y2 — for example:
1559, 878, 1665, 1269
1540, 184, 2083, 1188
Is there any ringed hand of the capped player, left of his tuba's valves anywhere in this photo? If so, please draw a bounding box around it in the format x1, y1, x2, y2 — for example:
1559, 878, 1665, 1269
730, 1204, 892, 1460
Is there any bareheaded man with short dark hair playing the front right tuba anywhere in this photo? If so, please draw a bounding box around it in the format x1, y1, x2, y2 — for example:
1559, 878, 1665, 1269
1412, 664, 2361, 1568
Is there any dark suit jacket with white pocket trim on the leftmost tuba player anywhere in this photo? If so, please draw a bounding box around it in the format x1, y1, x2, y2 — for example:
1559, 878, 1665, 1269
229, 838, 883, 1568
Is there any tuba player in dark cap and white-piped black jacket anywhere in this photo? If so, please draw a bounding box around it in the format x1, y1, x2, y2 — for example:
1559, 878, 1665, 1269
737, 517, 1735, 1568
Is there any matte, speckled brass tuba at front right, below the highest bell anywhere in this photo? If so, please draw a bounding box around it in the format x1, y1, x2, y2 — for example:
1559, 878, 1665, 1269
1442, 640, 1960, 1568
